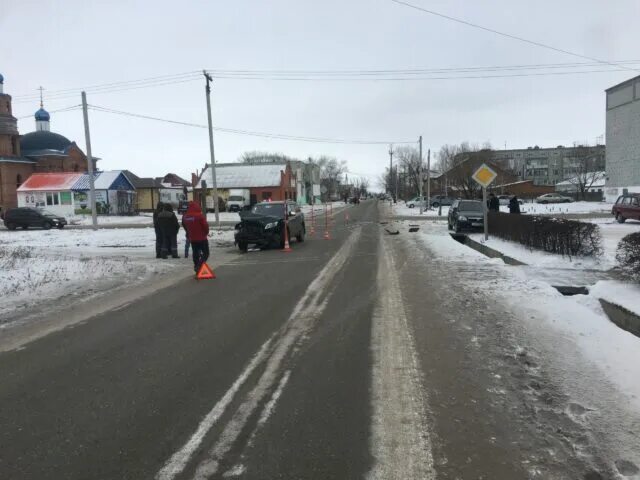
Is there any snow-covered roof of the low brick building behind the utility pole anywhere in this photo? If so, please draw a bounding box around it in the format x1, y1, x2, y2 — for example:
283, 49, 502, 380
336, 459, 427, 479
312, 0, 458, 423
196, 163, 287, 188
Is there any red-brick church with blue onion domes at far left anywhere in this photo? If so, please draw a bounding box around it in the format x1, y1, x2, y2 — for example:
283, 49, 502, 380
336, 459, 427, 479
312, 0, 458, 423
0, 74, 97, 211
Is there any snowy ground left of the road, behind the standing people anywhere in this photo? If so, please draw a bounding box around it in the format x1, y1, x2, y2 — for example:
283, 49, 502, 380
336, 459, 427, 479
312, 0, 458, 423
0, 228, 234, 329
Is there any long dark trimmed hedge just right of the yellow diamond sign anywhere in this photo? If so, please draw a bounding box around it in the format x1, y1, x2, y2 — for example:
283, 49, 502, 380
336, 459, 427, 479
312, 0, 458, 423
489, 212, 602, 257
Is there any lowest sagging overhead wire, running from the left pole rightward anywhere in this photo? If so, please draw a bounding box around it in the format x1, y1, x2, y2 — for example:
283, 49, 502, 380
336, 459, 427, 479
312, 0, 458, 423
89, 105, 415, 145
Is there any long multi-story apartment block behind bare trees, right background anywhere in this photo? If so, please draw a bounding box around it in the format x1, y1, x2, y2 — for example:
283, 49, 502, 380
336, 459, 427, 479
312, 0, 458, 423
491, 145, 605, 185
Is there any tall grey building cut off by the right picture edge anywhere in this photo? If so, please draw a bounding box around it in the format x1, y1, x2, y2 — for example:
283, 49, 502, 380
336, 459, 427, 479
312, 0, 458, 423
605, 76, 640, 201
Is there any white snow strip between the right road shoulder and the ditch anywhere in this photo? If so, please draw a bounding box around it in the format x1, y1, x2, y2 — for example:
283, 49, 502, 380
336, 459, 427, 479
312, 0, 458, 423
401, 221, 640, 446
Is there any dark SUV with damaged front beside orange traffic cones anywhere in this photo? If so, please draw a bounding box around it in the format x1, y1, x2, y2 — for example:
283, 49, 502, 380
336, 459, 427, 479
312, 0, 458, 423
235, 200, 306, 252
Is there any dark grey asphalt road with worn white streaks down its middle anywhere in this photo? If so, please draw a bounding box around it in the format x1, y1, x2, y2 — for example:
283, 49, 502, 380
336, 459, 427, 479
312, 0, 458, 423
0, 201, 633, 480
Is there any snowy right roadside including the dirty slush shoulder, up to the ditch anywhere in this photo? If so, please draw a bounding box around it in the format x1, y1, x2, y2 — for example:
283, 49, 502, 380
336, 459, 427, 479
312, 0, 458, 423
401, 222, 640, 478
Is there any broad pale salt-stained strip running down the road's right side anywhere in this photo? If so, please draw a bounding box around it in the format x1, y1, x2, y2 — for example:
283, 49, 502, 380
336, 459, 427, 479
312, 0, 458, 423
367, 237, 436, 480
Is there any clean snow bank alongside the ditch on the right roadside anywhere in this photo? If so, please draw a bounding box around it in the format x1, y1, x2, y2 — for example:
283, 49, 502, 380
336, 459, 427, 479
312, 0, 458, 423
418, 229, 640, 409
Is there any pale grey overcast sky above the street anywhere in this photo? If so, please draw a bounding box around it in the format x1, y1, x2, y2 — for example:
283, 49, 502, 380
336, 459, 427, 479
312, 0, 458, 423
0, 0, 640, 187
